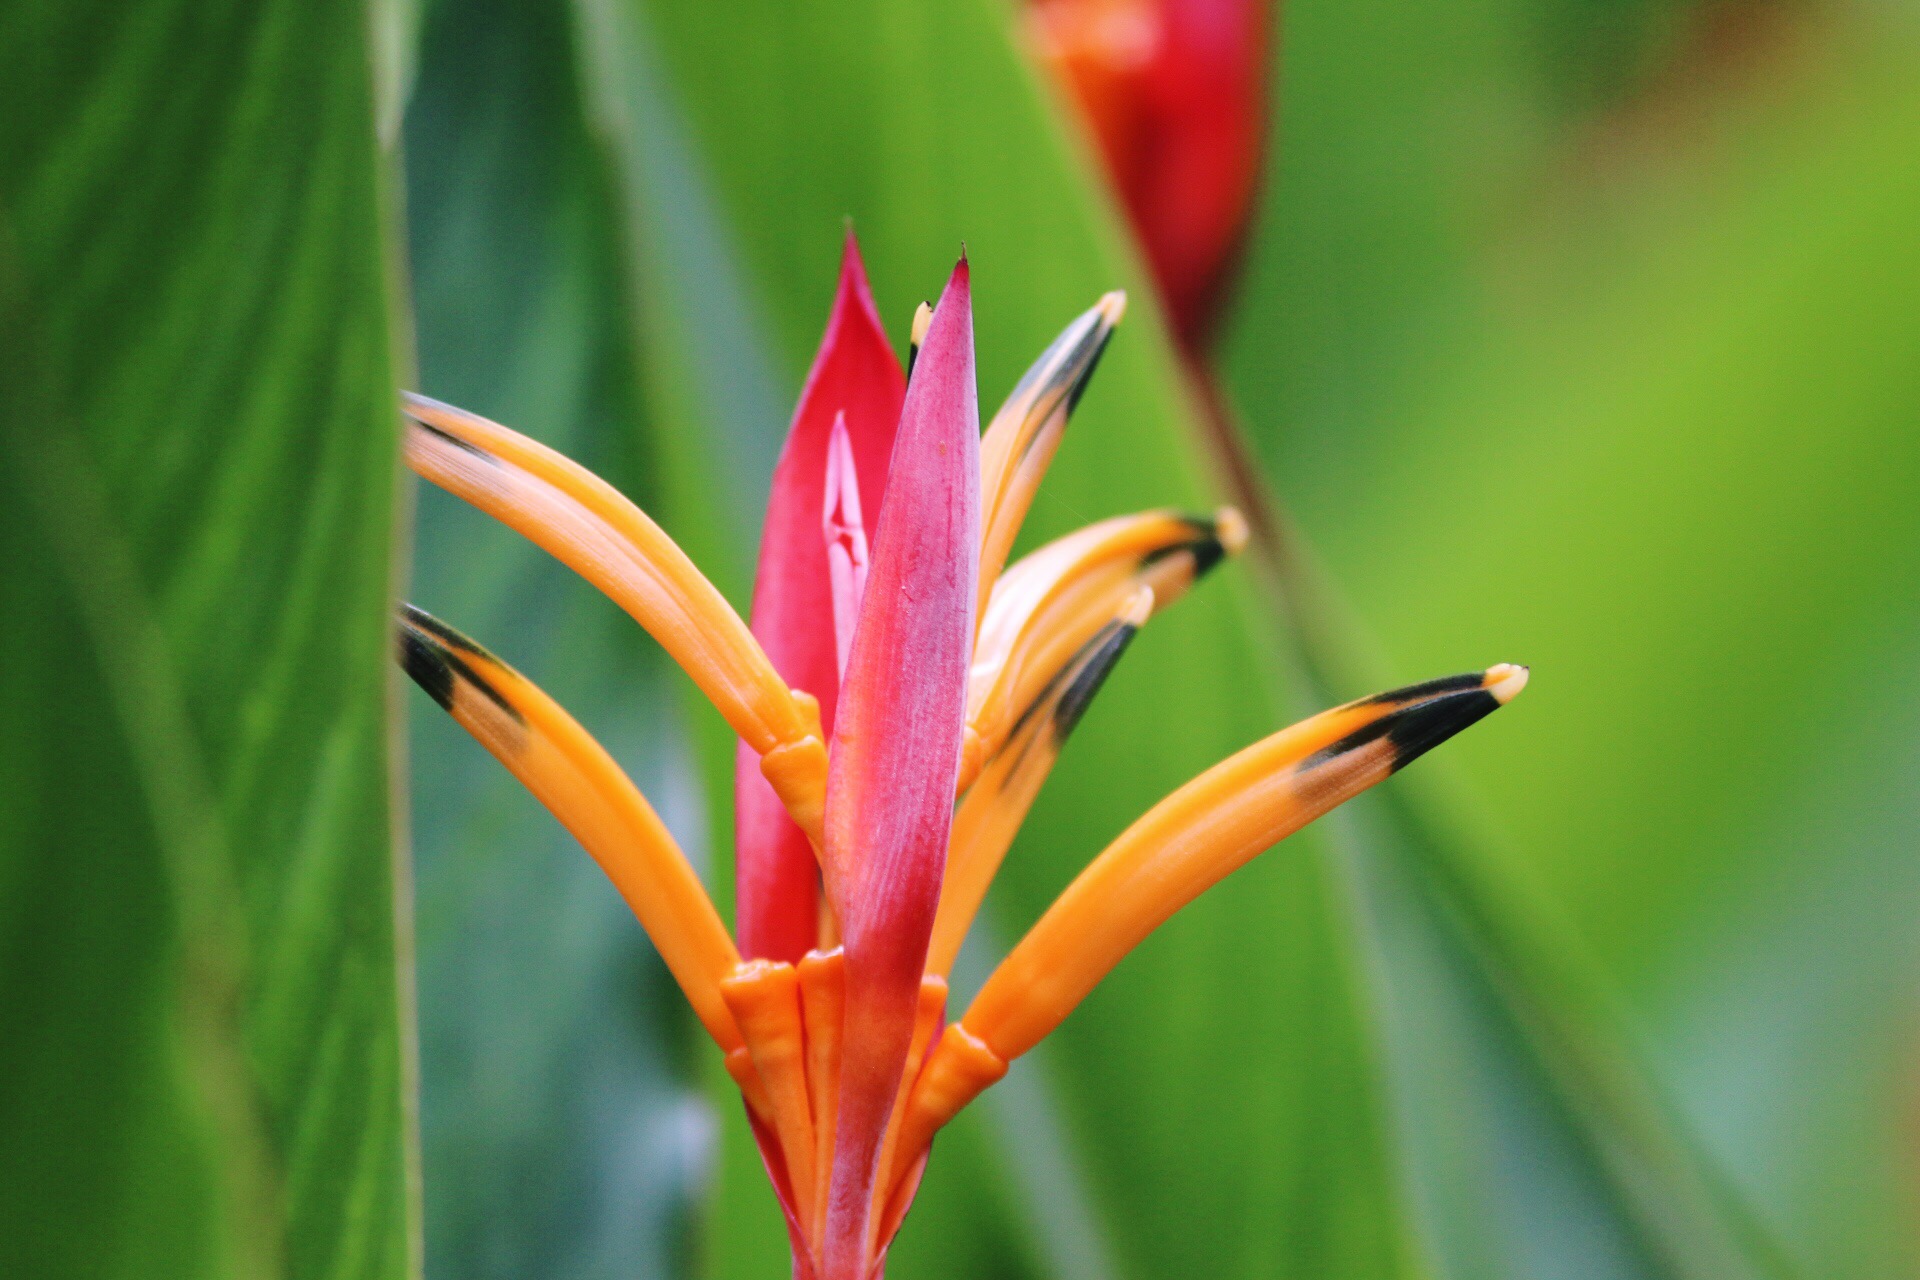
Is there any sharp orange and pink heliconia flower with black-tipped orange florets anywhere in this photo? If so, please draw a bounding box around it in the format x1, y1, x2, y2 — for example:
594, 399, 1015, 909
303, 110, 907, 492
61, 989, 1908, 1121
399, 236, 1526, 1280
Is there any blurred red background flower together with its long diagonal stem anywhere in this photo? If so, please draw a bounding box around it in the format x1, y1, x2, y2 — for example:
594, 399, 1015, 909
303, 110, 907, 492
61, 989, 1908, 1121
1025, 0, 1788, 1276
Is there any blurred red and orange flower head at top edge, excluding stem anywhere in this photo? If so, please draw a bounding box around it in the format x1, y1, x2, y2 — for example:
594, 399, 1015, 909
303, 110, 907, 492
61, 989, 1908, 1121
1027, 0, 1267, 351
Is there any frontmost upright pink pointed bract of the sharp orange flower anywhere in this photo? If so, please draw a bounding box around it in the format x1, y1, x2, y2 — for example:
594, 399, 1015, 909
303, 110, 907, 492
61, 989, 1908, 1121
822, 259, 979, 1280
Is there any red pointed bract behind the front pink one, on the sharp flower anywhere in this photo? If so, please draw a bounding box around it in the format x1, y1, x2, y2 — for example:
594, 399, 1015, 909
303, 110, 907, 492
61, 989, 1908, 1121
733, 232, 906, 961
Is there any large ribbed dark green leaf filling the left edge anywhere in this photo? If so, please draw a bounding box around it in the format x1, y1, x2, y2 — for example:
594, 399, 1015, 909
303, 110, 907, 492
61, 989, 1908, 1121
0, 0, 415, 1280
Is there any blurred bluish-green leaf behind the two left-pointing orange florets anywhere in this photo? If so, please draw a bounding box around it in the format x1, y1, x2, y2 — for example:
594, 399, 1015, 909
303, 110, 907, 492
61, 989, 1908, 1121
405, 0, 712, 1280
